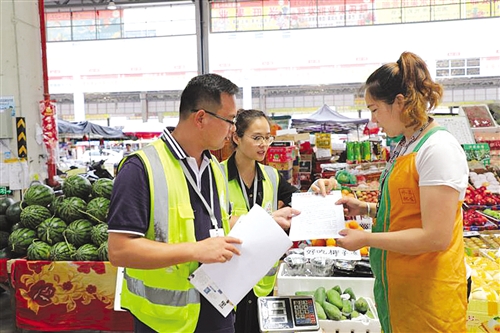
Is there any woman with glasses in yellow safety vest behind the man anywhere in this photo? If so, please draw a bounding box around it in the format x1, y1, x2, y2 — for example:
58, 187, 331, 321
222, 110, 299, 333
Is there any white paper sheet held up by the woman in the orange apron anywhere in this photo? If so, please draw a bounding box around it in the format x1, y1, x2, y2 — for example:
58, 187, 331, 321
290, 191, 345, 241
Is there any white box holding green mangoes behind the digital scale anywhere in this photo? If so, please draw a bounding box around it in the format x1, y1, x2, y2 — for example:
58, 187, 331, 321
277, 264, 381, 333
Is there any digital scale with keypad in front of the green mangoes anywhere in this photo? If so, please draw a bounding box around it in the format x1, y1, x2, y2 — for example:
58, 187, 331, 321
257, 296, 319, 332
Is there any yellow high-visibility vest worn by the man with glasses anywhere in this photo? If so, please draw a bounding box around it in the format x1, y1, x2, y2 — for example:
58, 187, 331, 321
120, 140, 230, 332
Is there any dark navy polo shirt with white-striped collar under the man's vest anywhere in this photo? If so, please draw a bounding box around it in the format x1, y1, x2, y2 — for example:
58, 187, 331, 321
108, 130, 234, 333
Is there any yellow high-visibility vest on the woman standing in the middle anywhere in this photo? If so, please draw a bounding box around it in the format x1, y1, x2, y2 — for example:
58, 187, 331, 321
221, 160, 279, 297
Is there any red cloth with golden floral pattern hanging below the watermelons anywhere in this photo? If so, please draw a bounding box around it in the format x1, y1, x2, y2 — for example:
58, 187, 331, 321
11, 259, 134, 331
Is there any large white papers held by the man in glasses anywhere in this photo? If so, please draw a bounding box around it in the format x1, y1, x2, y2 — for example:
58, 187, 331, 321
189, 205, 292, 316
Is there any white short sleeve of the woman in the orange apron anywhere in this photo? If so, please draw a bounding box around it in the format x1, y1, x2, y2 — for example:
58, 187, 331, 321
416, 131, 469, 200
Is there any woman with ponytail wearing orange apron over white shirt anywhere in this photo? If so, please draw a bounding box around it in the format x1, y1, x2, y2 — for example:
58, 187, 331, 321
337, 52, 468, 333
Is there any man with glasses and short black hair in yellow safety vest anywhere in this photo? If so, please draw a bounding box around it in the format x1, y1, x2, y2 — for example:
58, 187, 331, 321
108, 74, 241, 333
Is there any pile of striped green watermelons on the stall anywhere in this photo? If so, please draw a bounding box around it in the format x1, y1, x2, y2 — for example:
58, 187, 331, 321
4, 175, 113, 261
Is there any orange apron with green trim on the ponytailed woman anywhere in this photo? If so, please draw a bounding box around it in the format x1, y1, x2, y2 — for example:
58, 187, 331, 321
370, 127, 467, 333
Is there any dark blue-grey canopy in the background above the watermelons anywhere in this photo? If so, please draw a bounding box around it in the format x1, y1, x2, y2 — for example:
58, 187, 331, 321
57, 119, 126, 139
